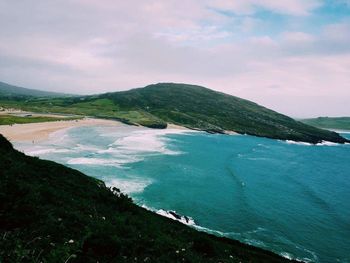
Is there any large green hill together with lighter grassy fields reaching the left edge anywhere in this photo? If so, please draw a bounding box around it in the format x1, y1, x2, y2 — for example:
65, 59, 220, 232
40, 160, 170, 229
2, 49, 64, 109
0, 83, 347, 143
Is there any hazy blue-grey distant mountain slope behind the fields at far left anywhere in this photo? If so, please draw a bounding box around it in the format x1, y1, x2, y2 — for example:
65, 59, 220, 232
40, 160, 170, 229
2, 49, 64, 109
0, 82, 67, 98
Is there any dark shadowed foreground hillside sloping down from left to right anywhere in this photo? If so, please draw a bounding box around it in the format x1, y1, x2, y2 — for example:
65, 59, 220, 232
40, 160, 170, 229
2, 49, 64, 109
0, 135, 296, 263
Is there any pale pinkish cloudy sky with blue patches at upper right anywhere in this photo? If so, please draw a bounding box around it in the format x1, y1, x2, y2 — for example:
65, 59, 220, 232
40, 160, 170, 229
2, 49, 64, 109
0, 0, 350, 118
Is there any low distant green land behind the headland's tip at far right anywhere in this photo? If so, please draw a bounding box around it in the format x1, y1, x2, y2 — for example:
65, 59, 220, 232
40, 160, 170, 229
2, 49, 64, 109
301, 117, 350, 130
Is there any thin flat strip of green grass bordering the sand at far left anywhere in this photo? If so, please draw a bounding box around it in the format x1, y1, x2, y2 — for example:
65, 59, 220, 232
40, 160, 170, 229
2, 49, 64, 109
0, 114, 79, 125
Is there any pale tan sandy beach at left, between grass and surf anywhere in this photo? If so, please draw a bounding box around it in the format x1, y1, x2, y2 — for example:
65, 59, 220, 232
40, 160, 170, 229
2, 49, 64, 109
0, 118, 122, 142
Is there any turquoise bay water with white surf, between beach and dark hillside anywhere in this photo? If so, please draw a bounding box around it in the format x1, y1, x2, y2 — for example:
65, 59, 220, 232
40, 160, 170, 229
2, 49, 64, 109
16, 126, 350, 262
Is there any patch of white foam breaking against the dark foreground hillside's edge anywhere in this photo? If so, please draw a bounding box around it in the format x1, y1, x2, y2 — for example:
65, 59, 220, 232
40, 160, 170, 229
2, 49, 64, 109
105, 178, 152, 194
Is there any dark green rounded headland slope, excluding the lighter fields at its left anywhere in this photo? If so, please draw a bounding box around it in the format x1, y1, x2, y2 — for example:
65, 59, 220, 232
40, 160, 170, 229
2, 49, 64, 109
100, 83, 346, 143
